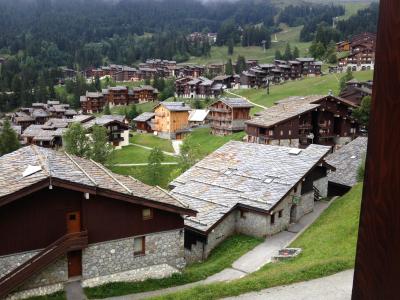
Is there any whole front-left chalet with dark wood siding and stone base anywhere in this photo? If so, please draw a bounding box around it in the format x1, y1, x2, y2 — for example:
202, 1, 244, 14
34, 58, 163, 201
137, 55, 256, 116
0, 146, 195, 299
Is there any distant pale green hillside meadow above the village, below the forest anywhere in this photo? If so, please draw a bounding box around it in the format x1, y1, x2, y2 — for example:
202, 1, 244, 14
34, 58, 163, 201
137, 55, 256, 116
188, 24, 311, 64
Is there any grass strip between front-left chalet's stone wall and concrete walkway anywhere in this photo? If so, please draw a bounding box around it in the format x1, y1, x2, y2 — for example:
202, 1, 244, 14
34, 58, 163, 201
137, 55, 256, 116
85, 235, 262, 299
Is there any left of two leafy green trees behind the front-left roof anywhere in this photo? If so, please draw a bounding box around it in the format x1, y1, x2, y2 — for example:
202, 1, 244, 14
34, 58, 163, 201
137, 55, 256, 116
63, 123, 90, 157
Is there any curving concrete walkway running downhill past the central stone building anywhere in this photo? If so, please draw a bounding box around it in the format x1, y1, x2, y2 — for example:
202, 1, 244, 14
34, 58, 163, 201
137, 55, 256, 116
106, 199, 335, 300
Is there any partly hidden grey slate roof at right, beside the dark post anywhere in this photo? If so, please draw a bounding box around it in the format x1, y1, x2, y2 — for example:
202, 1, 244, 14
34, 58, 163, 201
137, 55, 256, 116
326, 137, 368, 187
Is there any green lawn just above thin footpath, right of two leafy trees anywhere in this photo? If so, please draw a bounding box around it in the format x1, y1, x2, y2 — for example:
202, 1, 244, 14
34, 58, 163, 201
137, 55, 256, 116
108, 145, 177, 165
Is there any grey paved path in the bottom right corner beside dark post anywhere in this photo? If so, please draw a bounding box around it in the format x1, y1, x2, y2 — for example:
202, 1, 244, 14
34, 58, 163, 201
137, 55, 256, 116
226, 270, 354, 300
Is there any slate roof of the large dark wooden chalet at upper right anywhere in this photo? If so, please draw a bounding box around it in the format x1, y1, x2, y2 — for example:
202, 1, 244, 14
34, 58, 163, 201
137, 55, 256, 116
246, 96, 324, 127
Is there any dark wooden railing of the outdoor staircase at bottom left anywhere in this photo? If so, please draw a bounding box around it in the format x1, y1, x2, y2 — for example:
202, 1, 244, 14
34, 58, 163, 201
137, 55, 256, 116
0, 231, 88, 299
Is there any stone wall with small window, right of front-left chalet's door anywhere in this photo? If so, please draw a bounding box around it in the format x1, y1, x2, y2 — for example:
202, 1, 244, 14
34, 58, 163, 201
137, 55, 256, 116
82, 230, 185, 279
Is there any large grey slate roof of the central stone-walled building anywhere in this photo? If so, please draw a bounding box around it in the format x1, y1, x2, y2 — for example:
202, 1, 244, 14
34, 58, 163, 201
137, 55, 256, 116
171, 141, 330, 232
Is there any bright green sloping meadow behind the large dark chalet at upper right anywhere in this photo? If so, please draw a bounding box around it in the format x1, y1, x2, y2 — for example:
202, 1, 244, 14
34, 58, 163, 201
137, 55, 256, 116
227, 71, 373, 113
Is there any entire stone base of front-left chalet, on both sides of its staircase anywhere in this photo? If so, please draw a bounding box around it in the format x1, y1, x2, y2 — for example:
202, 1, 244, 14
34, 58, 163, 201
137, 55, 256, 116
0, 229, 186, 299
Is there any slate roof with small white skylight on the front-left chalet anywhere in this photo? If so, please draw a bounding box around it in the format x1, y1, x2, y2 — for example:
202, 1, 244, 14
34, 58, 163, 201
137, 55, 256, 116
0, 145, 194, 214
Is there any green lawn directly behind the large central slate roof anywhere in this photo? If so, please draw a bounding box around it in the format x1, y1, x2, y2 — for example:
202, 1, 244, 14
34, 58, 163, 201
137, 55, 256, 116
187, 128, 245, 157
